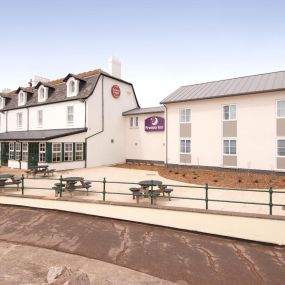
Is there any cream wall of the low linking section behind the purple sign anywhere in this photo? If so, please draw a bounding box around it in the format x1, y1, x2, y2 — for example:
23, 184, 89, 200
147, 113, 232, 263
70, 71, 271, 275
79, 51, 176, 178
125, 113, 165, 162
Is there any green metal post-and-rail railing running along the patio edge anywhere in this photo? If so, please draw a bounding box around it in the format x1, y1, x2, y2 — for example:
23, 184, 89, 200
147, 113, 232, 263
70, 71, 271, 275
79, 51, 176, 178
0, 175, 285, 215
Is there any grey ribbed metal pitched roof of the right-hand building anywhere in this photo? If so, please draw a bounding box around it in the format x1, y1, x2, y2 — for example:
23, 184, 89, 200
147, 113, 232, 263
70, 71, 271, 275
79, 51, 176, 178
160, 71, 285, 104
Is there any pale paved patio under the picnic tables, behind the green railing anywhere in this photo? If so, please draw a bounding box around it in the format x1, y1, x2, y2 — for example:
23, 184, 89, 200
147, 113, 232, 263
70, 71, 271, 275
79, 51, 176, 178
1, 167, 285, 215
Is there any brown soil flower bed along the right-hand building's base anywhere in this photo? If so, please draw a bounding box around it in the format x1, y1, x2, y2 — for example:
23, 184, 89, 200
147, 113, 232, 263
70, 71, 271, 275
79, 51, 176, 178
114, 163, 285, 189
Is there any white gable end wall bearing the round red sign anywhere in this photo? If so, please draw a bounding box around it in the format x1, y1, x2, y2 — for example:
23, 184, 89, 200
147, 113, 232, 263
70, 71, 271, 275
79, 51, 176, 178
87, 77, 137, 167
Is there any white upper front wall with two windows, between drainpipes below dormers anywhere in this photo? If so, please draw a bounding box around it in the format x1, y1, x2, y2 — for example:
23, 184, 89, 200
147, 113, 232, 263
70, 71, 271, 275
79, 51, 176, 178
29, 100, 85, 130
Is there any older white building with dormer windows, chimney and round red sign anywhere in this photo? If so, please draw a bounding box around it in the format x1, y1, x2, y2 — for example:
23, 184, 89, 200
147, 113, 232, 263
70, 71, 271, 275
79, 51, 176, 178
0, 59, 139, 170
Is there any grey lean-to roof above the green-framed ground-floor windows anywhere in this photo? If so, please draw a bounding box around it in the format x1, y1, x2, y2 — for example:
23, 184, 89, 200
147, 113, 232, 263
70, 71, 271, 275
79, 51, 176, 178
0, 128, 87, 141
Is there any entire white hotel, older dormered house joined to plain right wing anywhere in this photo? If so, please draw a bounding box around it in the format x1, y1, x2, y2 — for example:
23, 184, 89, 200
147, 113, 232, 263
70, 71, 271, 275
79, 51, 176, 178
0, 59, 285, 171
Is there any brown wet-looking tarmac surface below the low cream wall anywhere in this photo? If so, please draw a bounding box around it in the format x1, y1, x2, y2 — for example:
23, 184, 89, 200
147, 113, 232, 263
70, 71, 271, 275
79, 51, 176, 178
0, 205, 285, 285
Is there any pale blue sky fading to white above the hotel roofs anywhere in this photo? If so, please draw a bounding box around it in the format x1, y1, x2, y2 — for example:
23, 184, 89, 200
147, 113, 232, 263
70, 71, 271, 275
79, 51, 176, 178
0, 0, 285, 107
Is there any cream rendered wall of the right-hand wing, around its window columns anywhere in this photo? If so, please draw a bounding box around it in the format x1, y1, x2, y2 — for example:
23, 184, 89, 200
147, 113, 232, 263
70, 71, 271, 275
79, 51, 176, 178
167, 91, 285, 170
